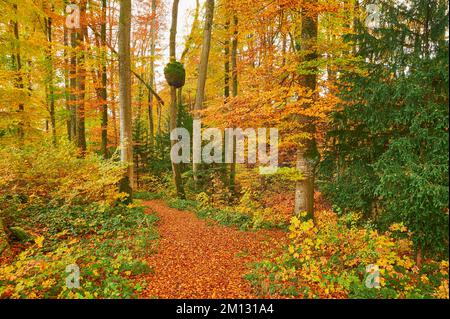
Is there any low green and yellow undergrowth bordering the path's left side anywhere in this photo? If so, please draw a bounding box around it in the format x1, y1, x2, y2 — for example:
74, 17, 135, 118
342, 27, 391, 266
0, 205, 157, 298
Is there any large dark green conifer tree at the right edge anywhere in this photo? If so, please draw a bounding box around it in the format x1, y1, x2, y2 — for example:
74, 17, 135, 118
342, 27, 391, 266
321, 0, 449, 265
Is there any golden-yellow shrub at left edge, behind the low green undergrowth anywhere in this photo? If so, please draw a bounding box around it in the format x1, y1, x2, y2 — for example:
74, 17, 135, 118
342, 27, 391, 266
0, 144, 125, 205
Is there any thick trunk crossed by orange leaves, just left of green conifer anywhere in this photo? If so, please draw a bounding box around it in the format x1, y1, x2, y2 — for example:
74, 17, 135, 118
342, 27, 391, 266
295, 0, 318, 218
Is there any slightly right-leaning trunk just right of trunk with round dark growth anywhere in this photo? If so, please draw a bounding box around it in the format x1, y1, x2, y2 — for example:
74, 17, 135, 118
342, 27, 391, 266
192, 0, 214, 185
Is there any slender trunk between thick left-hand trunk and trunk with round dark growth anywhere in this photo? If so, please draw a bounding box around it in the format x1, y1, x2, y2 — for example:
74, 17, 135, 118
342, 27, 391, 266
148, 0, 156, 152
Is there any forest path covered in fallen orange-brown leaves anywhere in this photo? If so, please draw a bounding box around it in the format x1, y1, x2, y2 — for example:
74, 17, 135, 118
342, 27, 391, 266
141, 200, 286, 299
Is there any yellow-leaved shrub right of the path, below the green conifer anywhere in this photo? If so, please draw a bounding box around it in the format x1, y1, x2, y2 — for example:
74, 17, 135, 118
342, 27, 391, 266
247, 211, 449, 298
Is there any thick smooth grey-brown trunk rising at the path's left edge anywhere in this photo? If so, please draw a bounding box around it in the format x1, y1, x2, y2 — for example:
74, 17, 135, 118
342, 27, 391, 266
119, 0, 133, 200
